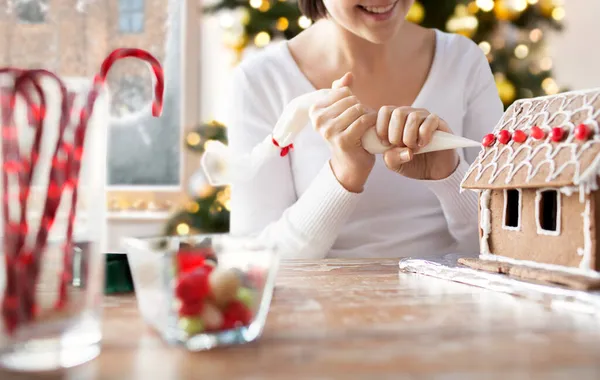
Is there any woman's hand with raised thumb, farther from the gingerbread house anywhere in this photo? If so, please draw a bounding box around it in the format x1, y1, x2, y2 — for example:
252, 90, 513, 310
309, 73, 377, 193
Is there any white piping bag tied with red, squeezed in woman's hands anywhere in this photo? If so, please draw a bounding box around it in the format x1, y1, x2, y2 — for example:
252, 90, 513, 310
201, 89, 481, 186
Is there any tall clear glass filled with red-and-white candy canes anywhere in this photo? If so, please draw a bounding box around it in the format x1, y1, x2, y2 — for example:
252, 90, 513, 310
0, 72, 109, 372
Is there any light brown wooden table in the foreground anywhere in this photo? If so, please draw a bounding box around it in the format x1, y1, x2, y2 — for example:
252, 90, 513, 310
0, 260, 600, 380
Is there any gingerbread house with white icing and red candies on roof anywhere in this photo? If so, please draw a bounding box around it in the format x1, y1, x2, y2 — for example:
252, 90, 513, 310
461, 89, 600, 285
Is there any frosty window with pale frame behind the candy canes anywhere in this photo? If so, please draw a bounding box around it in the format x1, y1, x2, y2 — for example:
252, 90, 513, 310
0, 0, 202, 221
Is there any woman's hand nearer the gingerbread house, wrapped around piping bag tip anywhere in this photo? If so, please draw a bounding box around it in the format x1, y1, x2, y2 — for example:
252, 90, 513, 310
377, 106, 458, 180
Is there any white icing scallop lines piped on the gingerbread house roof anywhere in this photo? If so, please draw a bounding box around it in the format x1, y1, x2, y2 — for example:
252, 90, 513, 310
465, 89, 600, 190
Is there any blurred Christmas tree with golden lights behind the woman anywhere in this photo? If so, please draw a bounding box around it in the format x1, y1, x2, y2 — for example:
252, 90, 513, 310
167, 0, 565, 234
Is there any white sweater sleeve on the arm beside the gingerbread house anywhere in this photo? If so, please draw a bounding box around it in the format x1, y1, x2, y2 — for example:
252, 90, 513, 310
426, 45, 504, 254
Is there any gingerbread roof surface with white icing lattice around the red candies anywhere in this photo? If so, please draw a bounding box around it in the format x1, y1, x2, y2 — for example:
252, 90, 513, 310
463, 89, 600, 191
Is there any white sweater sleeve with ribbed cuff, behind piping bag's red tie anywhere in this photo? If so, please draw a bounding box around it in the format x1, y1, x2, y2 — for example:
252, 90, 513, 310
223, 67, 360, 258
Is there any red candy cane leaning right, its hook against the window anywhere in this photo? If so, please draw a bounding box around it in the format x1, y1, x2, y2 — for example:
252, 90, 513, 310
55, 49, 164, 309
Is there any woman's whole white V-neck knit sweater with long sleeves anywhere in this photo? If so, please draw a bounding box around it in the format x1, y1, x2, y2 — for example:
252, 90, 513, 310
221, 31, 503, 258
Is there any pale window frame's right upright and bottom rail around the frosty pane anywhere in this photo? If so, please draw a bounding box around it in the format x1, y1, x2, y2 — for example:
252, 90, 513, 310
106, 0, 201, 221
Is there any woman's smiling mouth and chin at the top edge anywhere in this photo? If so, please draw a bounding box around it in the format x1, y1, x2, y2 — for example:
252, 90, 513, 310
325, 0, 414, 44
